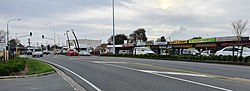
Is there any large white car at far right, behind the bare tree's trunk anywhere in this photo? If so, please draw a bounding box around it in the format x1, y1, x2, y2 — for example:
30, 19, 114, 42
215, 46, 250, 57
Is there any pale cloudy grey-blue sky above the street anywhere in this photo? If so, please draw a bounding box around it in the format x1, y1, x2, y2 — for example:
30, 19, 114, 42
0, 0, 250, 45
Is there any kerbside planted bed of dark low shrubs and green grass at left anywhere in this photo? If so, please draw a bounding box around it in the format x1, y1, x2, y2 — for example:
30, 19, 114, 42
0, 57, 55, 76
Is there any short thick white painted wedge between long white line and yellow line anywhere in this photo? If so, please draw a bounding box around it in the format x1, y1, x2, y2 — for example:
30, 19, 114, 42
139, 70, 213, 77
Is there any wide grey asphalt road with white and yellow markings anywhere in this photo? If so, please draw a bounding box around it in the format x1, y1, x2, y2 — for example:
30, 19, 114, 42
33, 55, 250, 91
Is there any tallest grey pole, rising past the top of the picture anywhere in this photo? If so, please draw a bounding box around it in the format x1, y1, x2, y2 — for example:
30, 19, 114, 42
112, 0, 115, 54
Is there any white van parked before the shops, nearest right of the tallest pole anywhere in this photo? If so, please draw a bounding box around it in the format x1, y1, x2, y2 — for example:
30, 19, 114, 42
133, 47, 155, 54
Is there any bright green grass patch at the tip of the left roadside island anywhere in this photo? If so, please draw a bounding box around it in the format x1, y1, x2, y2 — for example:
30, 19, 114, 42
26, 58, 55, 75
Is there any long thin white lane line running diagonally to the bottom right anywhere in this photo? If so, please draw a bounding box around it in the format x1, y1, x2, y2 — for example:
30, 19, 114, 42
104, 64, 233, 91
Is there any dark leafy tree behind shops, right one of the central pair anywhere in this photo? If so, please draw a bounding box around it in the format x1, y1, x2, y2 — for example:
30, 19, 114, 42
129, 28, 148, 43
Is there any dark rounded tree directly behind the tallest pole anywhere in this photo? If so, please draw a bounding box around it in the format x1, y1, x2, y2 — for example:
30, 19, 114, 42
108, 34, 128, 45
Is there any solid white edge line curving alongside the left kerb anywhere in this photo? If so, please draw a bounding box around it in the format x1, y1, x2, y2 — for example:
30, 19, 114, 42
39, 59, 102, 91
